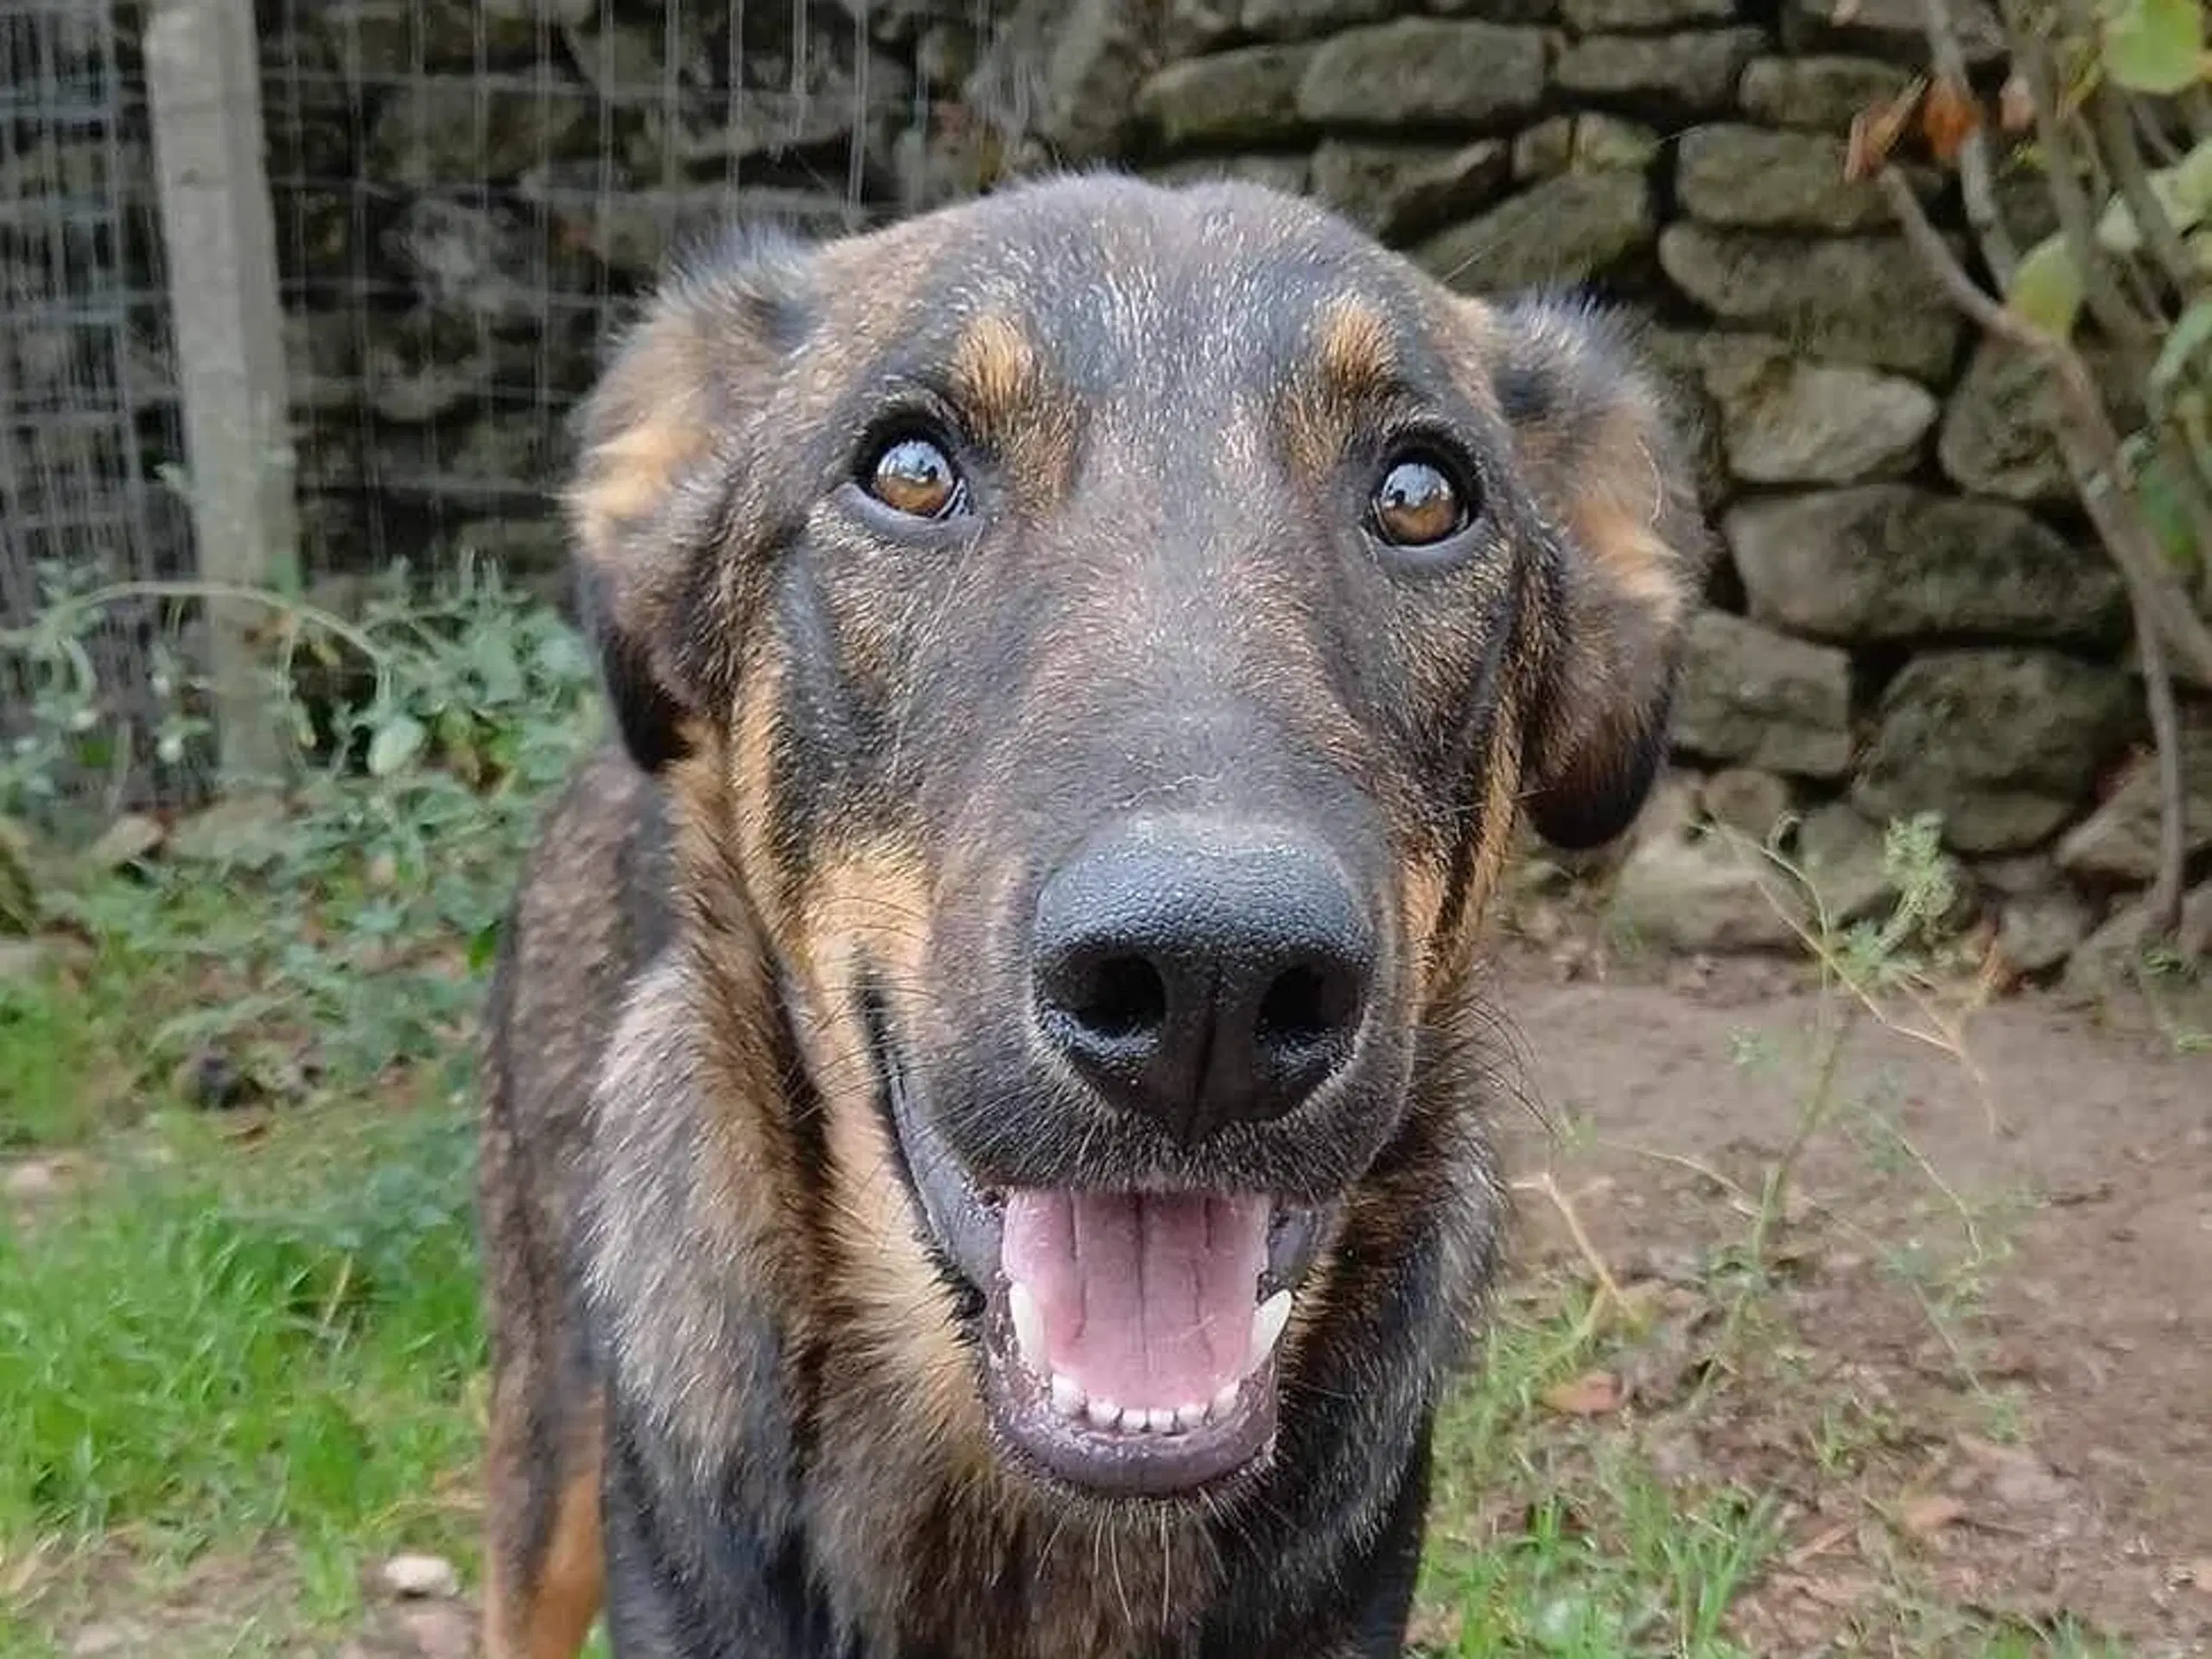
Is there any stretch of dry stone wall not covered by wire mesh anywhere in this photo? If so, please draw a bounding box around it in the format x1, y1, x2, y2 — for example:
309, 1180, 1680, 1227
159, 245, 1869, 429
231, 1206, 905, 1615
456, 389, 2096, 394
1137, 0, 2212, 973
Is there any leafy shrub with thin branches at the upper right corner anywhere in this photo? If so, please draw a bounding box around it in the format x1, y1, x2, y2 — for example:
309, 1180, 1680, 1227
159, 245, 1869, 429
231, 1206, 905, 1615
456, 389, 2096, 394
1849, 0, 2212, 936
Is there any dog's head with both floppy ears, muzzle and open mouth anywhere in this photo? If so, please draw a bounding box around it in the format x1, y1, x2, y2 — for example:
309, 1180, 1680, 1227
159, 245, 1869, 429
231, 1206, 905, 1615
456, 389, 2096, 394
570, 177, 1703, 1496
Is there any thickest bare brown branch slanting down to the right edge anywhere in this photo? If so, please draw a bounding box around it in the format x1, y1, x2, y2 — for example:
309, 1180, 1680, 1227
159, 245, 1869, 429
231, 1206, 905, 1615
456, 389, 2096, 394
1876, 166, 2212, 679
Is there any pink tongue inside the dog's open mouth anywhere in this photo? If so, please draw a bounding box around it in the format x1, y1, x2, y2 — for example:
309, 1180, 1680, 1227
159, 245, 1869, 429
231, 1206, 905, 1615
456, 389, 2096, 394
1002, 1190, 1269, 1409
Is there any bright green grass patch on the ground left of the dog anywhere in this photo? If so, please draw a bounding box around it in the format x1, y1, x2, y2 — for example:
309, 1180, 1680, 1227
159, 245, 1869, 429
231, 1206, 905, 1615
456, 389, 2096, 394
0, 1106, 482, 1601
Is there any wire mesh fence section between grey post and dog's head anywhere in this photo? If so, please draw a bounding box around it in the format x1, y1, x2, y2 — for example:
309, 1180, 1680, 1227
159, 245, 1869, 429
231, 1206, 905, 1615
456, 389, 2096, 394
264, 0, 973, 586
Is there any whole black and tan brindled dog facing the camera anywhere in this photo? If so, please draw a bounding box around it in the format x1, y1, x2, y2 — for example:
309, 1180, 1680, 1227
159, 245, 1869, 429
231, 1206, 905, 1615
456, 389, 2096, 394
482, 175, 1706, 1659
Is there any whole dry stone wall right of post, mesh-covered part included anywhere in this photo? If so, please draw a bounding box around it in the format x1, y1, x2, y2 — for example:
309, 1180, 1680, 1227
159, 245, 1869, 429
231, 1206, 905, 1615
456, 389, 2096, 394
242, 0, 2212, 971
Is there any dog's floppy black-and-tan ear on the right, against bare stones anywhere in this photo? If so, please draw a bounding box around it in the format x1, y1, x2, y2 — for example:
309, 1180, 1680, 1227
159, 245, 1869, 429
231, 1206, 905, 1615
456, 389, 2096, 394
1496, 296, 1712, 849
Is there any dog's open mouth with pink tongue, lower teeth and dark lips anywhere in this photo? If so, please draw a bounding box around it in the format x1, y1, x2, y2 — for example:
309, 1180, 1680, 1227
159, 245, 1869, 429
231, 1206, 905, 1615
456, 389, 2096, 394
869, 1000, 1327, 1497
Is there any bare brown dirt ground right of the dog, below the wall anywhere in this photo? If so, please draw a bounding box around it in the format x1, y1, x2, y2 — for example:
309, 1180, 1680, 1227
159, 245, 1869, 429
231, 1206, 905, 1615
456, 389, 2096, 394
1497, 949, 2212, 1655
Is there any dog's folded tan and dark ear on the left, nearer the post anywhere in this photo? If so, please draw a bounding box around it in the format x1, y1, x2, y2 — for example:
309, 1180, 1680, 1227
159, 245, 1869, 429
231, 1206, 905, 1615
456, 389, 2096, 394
564, 237, 807, 772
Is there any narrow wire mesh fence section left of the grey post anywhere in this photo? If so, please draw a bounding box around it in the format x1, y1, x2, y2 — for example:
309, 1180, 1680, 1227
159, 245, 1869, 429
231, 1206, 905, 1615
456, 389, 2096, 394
0, 0, 194, 827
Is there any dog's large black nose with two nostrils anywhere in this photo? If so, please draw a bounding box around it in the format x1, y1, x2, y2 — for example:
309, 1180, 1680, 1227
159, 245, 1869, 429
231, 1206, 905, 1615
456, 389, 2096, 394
1033, 827, 1374, 1141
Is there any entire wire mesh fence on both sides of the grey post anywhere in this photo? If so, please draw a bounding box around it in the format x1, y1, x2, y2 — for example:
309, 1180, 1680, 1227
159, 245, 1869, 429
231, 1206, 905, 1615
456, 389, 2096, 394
0, 0, 1017, 827
